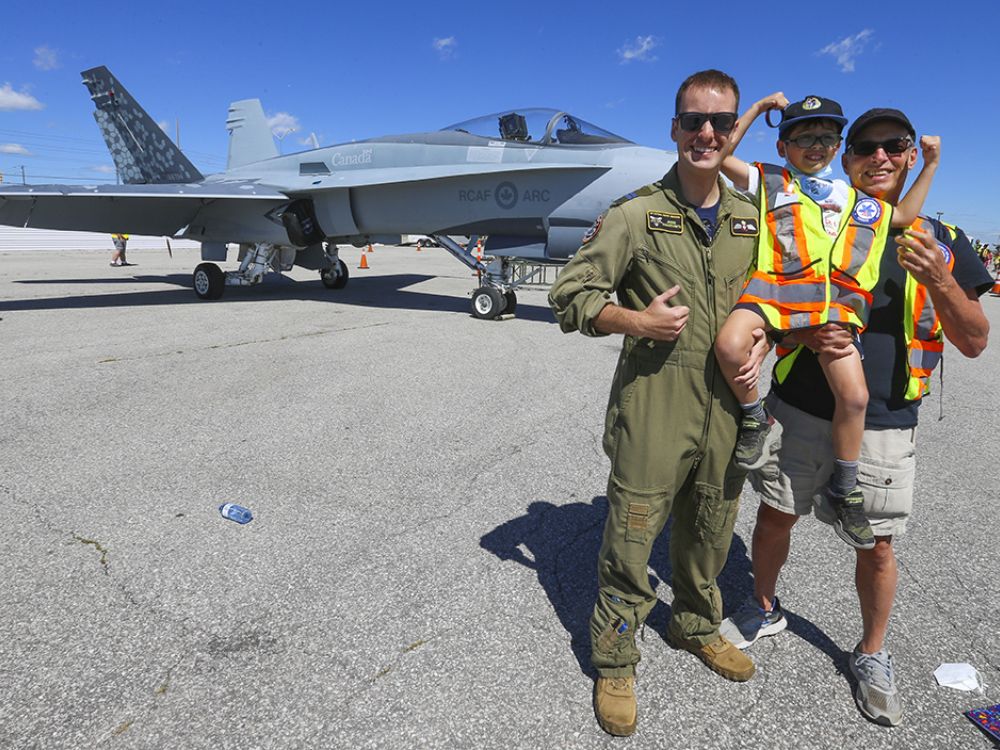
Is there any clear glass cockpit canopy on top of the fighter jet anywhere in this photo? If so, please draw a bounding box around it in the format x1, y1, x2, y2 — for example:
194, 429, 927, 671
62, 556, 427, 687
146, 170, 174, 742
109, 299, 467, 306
443, 108, 631, 146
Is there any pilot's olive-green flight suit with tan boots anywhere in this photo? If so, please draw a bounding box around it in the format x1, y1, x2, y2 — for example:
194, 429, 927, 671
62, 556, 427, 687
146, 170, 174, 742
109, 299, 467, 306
549, 79, 758, 734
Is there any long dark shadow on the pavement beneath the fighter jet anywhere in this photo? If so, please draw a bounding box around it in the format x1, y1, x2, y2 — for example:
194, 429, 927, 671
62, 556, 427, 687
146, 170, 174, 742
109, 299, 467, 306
0, 274, 555, 324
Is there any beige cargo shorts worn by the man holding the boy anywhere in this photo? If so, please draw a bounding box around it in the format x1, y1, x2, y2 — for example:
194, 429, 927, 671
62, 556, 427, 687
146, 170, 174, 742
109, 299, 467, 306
750, 393, 917, 536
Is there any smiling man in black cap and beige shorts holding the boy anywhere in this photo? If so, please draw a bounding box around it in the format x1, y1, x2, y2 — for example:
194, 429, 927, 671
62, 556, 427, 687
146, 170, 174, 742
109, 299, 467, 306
720, 109, 992, 726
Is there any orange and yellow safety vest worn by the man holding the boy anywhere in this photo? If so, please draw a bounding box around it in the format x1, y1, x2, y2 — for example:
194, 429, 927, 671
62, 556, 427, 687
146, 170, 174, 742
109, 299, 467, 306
774, 216, 958, 401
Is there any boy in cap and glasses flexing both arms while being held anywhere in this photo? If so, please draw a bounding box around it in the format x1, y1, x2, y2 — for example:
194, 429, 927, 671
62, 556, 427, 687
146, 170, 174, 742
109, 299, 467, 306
715, 92, 940, 549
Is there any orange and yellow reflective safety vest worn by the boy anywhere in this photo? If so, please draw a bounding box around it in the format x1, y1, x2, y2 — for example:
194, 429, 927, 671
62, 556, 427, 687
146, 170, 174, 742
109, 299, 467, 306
739, 164, 892, 331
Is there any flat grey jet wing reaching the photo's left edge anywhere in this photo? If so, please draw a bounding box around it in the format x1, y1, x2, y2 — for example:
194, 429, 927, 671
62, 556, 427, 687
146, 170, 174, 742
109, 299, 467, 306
0, 181, 288, 236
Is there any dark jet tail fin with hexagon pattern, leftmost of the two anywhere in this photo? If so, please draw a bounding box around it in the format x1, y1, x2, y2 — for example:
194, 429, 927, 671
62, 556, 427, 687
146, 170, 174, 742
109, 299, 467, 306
80, 66, 203, 185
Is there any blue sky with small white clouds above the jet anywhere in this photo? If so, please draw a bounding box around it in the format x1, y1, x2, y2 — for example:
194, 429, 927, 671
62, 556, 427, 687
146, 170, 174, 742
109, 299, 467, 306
0, 0, 1000, 244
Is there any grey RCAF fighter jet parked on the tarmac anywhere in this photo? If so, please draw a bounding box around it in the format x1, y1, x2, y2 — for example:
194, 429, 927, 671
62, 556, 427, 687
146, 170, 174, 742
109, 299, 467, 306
0, 67, 676, 318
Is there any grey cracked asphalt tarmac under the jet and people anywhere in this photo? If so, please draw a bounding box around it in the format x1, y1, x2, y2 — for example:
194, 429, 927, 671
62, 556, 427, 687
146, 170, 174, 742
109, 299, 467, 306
0, 246, 1000, 750
